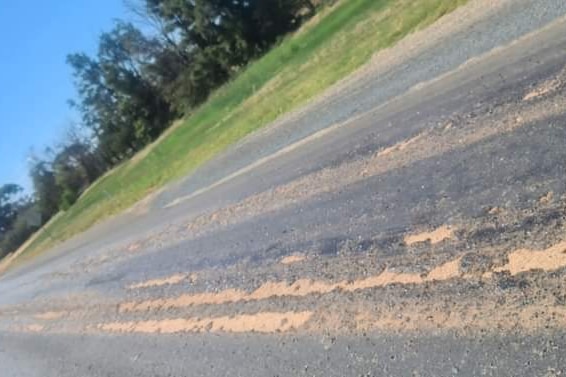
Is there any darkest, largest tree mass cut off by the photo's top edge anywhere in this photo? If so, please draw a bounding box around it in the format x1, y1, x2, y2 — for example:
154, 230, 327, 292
131, 0, 315, 113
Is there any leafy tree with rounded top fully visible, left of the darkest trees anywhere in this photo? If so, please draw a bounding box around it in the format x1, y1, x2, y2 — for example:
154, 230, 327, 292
67, 22, 174, 165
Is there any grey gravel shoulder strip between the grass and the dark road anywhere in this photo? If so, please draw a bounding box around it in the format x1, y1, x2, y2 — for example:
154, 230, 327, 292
6, 0, 566, 278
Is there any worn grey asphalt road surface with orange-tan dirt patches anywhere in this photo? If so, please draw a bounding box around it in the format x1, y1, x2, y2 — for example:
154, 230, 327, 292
0, 1, 566, 377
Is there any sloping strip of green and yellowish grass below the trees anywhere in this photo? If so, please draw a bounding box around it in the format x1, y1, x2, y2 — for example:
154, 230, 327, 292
17, 0, 467, 262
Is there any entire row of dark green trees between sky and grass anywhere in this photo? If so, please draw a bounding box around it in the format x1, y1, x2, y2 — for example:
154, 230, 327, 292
0, 0, 321, 256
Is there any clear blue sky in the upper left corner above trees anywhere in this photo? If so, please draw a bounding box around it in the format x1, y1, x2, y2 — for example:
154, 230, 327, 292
0, 0, 127, 189
